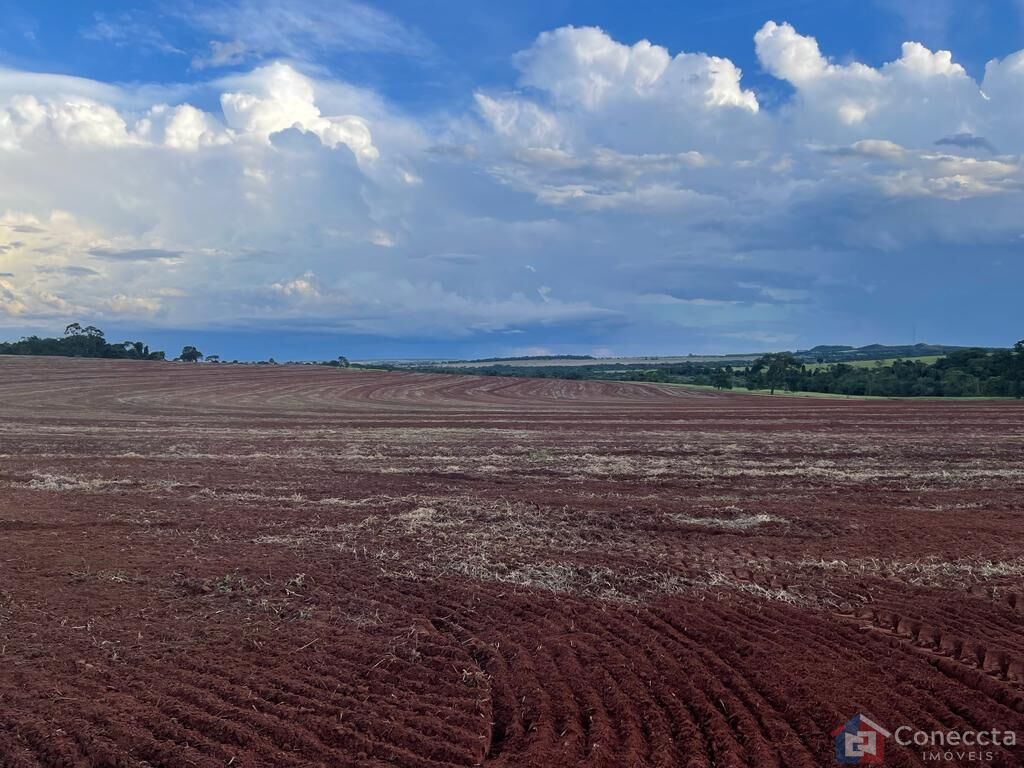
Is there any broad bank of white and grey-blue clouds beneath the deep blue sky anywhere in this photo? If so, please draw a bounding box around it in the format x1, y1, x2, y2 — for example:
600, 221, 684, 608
0, 15, 1024, 351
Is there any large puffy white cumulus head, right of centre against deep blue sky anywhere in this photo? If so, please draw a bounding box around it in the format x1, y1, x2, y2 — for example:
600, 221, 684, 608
476, 27, 765, 169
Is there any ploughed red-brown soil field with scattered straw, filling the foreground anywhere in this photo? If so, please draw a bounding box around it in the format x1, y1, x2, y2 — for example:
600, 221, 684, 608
0, 358, 1024, 768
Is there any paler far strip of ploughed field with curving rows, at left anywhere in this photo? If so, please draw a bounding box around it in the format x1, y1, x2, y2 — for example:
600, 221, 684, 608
0, 358, 716, 415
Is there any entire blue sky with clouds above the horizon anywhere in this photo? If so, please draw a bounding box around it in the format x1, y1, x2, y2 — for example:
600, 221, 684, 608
0, 0, 1024, 359
